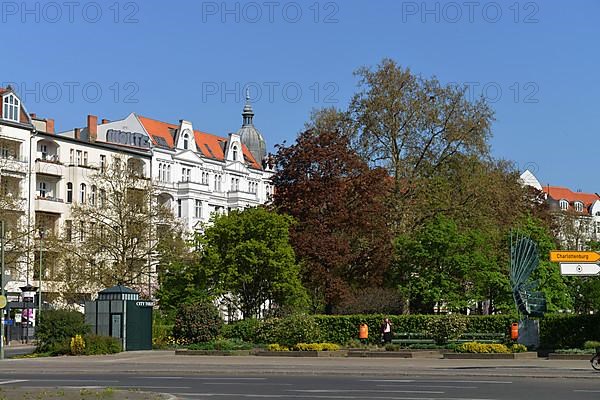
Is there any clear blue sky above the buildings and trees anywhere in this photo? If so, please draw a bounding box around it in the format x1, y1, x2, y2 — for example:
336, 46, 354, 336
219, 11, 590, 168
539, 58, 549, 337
0, 0, 600, 192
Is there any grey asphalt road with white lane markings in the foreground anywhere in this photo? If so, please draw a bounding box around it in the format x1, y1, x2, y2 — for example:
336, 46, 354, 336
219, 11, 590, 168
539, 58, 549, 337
0, 371, 600, 400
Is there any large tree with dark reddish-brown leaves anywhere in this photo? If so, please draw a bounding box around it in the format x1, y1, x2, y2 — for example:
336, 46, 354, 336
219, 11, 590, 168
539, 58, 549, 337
273, 129, 393, 313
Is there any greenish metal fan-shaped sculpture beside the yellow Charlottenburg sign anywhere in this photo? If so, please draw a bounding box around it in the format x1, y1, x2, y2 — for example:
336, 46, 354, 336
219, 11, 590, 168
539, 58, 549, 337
510, 232, 546, 317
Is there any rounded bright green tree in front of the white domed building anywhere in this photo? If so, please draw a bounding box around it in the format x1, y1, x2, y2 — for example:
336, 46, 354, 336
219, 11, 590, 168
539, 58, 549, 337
197, 208, 307, 318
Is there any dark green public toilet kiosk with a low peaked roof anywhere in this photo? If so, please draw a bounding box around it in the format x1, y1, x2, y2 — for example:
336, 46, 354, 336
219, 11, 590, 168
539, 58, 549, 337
85, 285, 154, 351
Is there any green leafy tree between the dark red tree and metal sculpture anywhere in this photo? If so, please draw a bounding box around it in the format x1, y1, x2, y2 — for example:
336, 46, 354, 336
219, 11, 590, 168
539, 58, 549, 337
393, 215, 510, 313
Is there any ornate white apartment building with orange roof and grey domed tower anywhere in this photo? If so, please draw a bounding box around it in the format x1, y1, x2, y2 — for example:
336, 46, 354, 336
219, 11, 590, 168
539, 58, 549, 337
61, 95, 273, 231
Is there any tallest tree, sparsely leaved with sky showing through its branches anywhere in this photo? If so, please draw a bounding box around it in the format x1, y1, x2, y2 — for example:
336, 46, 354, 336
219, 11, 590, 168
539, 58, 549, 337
348, 59, 493, 233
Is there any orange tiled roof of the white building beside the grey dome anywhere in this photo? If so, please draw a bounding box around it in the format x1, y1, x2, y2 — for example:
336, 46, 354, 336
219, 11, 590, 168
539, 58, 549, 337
137, 115, 261, 169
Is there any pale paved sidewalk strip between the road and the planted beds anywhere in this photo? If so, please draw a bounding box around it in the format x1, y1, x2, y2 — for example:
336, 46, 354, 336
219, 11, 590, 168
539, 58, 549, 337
0, 351, 600, 379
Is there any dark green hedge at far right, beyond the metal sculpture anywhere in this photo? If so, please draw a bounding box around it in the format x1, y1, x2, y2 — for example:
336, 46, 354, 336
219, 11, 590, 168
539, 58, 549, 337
540, 314, 600, 350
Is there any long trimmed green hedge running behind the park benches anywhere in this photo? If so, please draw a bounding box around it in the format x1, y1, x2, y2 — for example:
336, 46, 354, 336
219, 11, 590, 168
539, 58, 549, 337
221, 314, 516, 344
